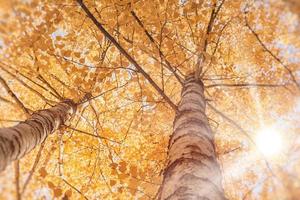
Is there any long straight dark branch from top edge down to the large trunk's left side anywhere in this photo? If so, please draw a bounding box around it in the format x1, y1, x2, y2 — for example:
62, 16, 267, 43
77, 0, 177, 111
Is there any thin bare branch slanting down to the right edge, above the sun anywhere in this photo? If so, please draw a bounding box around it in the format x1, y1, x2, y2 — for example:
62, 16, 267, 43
245, 16, 300, 90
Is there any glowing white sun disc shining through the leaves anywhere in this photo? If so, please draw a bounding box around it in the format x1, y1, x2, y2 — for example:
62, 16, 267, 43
255, 127, 283, 157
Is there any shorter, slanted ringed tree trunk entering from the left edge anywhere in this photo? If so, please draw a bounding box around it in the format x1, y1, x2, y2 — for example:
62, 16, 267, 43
0, 100, 76, 171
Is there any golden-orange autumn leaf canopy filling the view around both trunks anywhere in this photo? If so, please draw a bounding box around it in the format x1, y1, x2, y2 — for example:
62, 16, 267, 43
0, 0, 300, 200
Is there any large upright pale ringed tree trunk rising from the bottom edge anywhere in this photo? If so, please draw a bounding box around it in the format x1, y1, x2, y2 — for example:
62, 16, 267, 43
159, 75, 225, 200
